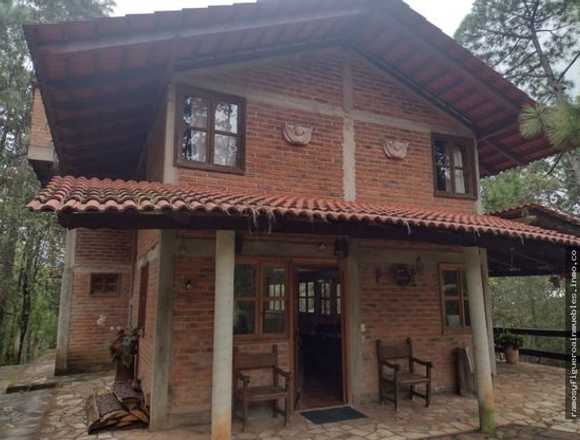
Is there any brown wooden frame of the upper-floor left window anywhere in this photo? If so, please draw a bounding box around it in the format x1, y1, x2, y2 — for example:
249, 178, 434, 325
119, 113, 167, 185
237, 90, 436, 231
173, 86, 246, 174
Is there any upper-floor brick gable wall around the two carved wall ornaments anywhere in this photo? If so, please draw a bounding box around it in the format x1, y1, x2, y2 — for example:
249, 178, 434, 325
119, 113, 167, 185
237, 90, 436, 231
163, 49, 475, 212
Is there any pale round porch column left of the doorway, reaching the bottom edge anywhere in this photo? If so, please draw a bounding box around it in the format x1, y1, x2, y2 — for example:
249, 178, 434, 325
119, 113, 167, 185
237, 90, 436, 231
211, 231, 236, 440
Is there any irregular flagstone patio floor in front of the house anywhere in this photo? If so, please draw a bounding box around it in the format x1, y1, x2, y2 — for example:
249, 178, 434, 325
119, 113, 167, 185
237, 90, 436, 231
0, 358, 580, 440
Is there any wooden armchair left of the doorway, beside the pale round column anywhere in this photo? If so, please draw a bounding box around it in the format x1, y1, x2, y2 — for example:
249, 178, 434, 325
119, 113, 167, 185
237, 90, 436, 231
233, 345, 292, 432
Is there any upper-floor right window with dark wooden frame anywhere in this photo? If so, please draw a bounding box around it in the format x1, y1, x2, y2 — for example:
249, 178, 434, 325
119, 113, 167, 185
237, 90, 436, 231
433, 136, 475, 197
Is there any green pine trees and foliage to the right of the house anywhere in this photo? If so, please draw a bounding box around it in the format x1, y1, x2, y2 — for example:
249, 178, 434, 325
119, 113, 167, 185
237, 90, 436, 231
455, 0, 580, 352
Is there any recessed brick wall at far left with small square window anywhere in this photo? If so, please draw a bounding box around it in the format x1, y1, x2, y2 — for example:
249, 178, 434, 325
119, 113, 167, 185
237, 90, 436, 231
68, 229, 134, 371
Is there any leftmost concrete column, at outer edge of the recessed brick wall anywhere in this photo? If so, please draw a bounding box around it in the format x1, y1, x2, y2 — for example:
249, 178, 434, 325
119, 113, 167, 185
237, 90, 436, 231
54, 229, 76, 376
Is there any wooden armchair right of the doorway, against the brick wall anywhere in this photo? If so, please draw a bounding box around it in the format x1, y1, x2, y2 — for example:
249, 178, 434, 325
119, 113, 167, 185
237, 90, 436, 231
377, 338, 433, 411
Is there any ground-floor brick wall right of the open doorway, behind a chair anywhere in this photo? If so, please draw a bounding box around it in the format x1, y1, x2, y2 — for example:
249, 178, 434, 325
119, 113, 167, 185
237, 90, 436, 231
359, 242, 471, 401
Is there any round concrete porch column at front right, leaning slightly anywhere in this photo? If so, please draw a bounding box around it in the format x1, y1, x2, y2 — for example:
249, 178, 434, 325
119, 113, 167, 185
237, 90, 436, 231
464, 247, 496, 433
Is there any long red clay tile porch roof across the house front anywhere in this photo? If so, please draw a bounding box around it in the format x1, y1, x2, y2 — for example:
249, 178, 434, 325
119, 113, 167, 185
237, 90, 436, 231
28, 177, 580, 246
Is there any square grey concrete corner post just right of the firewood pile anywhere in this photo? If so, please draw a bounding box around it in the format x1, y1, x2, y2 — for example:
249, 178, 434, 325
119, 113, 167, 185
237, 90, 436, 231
149, 230, 177, 431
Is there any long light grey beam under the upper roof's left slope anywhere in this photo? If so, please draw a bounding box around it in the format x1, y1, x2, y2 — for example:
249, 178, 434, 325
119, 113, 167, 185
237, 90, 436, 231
38, 7, 368, 55
